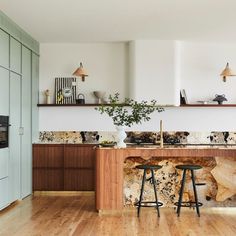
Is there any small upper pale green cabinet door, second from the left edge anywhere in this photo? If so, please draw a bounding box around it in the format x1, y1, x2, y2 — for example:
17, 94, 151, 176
10, 37, 21, 74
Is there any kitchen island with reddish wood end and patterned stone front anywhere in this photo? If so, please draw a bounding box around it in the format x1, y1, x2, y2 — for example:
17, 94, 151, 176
96, 146, 236, 212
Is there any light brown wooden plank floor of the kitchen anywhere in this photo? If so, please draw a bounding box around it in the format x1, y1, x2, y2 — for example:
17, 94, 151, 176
0, 196, 236, 236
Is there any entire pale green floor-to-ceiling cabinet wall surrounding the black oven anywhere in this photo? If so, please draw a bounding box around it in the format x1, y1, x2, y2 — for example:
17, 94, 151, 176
0, 11, 39, 210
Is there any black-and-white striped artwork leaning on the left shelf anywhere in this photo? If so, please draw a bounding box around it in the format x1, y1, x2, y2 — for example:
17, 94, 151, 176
55, 77, 76, 104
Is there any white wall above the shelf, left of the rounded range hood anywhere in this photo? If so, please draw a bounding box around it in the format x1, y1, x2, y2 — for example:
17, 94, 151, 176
39, 43, 127, 104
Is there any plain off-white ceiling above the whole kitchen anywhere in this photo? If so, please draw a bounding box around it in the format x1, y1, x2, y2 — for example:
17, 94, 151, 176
0, 0, 236, 43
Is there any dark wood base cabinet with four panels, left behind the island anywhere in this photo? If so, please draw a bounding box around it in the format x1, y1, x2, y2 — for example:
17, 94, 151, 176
33, 144, 95, 191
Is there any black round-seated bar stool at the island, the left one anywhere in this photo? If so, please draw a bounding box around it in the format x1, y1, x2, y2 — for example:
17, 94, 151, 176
135, 165, 163, 217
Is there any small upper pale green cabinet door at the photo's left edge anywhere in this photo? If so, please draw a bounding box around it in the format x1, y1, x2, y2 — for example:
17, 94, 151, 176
0, 29, 9, 68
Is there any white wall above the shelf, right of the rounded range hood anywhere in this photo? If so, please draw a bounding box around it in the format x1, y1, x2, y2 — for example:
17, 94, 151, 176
180, 42, 236, 104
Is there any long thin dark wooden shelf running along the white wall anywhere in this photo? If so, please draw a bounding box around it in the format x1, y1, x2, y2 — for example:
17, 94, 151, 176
37, 103, 236, 107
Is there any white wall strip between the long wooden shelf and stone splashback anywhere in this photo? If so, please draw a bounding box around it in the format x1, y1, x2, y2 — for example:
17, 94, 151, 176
39, 107, 236, 132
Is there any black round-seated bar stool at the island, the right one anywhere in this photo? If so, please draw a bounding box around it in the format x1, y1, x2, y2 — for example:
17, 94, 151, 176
175, 165, 203, 217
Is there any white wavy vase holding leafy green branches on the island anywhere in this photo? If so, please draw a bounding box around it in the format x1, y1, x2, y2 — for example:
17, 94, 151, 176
95, 93, 164, 147
